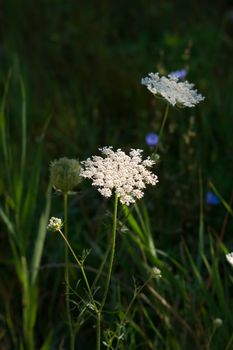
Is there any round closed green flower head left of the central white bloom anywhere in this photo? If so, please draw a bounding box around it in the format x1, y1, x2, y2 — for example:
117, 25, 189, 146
50, 158, 81, 193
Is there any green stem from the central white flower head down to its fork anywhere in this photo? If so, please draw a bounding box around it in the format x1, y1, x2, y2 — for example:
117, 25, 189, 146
100, 194, 118, 311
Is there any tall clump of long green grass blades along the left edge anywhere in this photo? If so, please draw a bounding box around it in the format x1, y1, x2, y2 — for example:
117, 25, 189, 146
0, 75, 50, 350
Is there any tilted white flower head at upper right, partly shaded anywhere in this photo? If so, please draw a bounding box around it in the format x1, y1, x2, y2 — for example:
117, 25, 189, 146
141, 73, 205, 107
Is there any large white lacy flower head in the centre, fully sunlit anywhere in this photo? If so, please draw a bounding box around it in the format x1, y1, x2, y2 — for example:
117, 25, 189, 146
80, 147, 158, 205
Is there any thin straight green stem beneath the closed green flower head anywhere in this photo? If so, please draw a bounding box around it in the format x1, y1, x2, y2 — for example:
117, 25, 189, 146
64, 193, 74, 350
